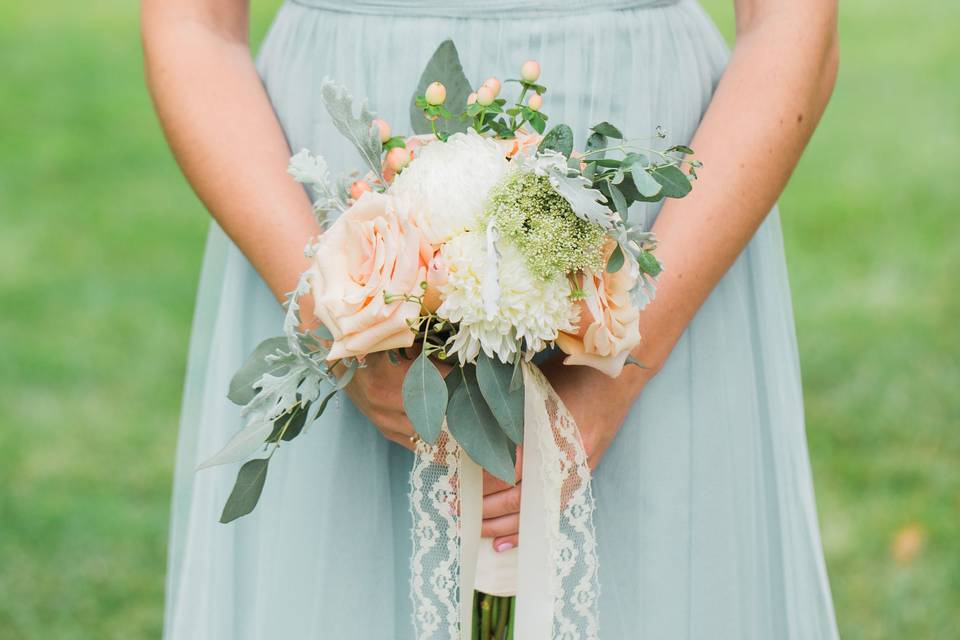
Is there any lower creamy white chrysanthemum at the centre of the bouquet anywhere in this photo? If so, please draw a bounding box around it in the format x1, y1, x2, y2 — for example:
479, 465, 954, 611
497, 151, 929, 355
437, 232, 579, 364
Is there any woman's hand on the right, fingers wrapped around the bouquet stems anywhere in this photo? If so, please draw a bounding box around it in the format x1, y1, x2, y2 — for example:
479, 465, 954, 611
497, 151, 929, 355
480, 359, 652, 551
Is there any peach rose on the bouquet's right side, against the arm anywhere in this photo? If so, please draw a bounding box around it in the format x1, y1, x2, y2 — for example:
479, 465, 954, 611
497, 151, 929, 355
557, 240, 640, 378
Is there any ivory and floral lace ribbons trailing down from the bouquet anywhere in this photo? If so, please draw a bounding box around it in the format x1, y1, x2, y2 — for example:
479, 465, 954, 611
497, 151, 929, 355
410, 363, 600, 640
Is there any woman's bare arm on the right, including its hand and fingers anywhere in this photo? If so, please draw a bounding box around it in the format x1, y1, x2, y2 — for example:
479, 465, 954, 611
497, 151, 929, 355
484, 0, 838, 546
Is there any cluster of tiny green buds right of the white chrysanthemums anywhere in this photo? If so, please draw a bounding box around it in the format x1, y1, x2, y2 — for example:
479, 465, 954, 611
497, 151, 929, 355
487, 171, 605, 280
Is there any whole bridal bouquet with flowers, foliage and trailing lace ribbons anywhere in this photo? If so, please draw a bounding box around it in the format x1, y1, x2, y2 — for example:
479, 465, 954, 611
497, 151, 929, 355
202, 41, 699, 640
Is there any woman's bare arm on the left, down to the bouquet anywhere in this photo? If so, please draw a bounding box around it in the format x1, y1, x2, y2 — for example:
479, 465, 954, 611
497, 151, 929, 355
142, 0, 319, 299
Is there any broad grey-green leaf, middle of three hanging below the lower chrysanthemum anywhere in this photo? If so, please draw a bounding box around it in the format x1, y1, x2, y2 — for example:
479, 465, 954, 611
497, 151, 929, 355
447, 365, 517, 484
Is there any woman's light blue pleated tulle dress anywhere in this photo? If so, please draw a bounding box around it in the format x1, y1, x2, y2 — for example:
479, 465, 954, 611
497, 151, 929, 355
165, 0, 837, 640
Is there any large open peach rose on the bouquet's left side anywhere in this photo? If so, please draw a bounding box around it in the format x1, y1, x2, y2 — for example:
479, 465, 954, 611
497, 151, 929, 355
311, 191, 433, 360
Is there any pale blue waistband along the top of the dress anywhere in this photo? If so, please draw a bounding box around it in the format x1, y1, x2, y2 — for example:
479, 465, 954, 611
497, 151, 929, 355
288, 0, 680, 19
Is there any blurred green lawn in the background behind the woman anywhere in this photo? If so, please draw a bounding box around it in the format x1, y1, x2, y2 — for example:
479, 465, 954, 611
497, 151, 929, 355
0, 0, 960, 640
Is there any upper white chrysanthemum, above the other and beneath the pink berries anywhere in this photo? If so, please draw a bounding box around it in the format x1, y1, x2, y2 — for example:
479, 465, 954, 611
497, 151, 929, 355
388, 129, 510, 244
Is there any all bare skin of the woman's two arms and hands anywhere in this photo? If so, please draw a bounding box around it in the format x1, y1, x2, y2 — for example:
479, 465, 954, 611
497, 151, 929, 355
141, 0, 838, 550
